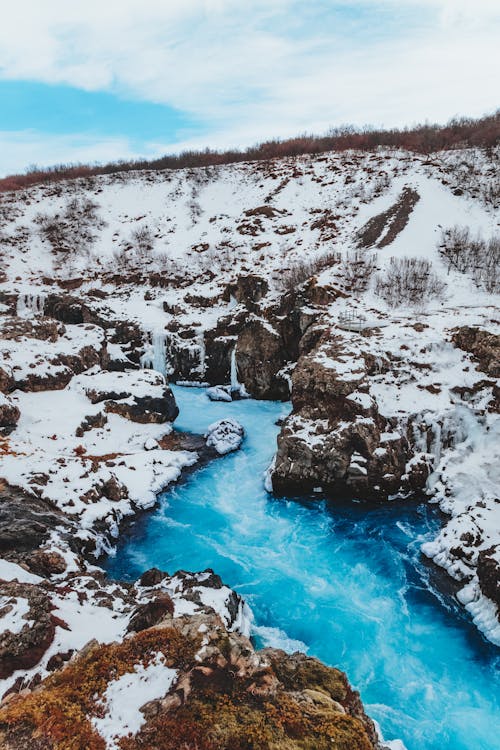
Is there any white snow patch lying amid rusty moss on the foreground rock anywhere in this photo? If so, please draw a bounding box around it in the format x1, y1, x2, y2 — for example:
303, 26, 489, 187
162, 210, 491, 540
92, 652, 178, 750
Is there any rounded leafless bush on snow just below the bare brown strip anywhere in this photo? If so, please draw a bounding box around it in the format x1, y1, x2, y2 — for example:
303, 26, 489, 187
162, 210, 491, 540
375, 258, 446, 307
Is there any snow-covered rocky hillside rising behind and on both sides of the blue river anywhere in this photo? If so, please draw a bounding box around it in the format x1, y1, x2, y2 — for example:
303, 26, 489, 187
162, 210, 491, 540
0, 142, 500, 736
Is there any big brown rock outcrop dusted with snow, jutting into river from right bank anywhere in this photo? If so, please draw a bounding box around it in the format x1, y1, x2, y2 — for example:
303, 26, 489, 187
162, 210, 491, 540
272, 333, 428, 500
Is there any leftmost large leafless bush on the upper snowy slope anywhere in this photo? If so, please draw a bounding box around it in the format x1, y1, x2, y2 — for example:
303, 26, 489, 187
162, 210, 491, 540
34, 198, 105, 253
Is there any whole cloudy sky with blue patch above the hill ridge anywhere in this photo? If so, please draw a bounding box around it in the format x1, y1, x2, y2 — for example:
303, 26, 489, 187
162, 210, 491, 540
0, 0, 500, 175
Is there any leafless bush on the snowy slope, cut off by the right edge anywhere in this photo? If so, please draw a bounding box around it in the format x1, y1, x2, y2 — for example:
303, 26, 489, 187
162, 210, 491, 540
439, 226, 500, 294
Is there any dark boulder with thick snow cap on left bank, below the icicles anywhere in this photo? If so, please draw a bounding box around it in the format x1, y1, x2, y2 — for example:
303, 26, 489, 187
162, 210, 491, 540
70, 369, 179, 424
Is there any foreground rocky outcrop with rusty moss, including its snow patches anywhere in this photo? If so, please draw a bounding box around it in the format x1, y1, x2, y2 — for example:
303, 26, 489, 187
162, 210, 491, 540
0, 571, 379, 750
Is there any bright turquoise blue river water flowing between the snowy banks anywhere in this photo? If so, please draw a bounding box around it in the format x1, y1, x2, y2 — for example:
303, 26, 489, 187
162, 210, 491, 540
106, 388, 500, 750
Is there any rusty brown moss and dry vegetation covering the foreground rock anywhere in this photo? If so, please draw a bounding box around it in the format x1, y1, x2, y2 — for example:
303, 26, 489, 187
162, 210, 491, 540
0, 627, 373, 750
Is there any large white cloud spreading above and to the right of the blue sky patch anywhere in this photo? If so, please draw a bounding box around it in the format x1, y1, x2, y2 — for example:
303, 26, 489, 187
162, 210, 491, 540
0, 0, 500, 173
